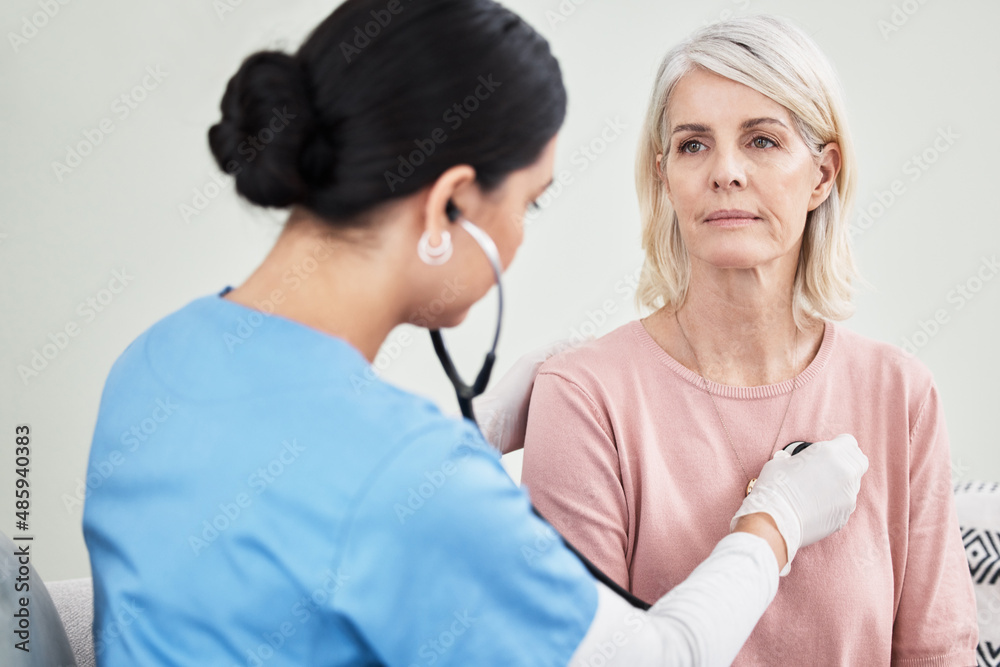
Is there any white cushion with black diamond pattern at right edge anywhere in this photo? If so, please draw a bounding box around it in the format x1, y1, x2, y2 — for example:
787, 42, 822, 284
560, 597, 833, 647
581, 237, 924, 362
955, 482, 1000, 667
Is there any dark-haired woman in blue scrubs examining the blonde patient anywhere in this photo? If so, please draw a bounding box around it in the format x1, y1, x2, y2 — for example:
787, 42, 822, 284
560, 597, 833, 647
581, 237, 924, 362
83, 0, 868, 665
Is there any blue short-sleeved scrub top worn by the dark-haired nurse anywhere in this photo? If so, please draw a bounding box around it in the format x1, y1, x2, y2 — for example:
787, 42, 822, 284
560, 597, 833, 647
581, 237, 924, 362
83, 287, 597, 667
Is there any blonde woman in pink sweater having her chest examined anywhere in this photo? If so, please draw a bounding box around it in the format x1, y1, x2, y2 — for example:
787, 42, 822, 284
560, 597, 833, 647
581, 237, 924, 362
522, 16, 977, 667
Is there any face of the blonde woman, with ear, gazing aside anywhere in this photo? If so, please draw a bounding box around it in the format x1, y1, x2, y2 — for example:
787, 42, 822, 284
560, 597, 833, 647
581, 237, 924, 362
660, 68, 840, 269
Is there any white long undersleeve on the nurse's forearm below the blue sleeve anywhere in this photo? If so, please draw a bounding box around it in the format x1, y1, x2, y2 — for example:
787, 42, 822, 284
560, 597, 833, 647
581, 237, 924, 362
570, 532, 778, 667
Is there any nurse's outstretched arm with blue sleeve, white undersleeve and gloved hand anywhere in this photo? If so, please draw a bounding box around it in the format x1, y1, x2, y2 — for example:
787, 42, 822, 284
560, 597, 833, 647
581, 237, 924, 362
330, 420, 867, 667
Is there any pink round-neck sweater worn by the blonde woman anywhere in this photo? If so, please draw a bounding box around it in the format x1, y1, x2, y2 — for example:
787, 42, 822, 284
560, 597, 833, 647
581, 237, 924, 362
522, 320, 978, 667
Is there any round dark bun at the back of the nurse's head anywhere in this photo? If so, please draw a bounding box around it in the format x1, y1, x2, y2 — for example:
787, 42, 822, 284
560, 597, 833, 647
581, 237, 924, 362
208, 51, 332, 208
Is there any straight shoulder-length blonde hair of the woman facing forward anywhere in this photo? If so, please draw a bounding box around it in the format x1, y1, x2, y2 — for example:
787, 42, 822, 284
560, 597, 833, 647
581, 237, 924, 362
635, 15, 858, 326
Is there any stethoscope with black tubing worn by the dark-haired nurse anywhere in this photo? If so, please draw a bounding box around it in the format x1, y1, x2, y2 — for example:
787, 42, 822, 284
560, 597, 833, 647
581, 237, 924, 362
430, 201, 812, 610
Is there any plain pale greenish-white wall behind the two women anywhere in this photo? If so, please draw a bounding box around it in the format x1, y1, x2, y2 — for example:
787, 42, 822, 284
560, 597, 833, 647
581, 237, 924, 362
0, 0, 1000, 579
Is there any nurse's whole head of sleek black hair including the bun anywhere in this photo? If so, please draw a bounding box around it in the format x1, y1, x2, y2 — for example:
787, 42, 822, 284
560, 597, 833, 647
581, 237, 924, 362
208, 0, 566, 225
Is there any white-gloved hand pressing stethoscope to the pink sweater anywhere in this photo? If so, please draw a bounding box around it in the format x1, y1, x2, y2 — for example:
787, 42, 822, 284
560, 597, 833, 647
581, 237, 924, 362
730, 433, 868, 576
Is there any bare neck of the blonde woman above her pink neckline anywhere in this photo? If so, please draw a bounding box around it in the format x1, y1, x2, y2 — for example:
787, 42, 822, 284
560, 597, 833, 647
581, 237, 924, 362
643, 266, 823, 387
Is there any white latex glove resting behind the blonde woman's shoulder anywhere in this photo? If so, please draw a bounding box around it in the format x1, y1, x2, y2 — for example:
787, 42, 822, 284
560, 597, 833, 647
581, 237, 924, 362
472, 337, 593, 454
